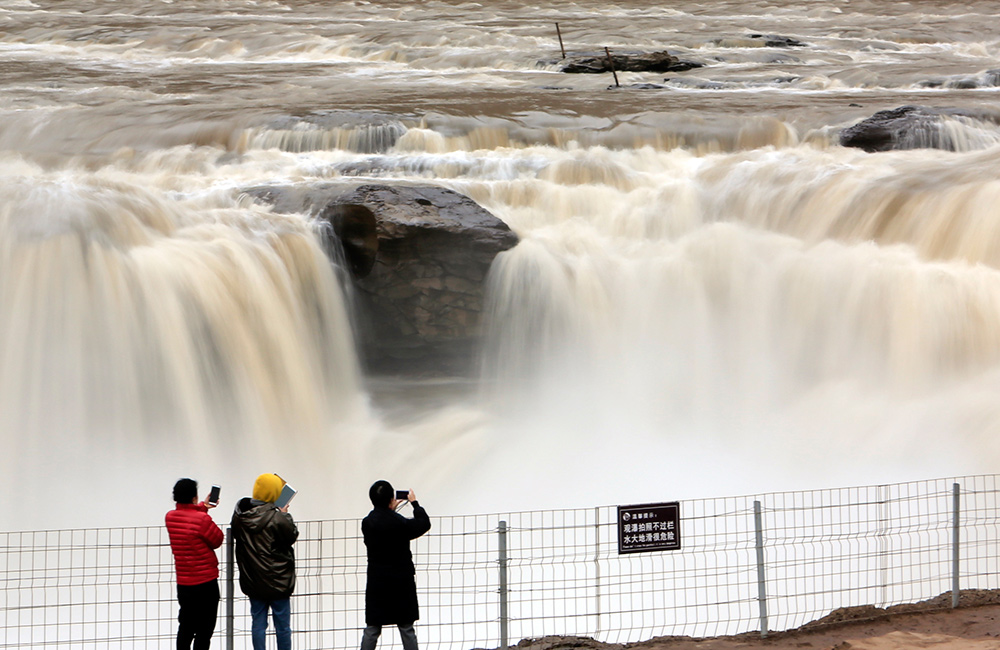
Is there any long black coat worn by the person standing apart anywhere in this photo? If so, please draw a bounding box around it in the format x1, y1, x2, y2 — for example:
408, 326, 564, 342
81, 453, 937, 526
361, 501, 431, 625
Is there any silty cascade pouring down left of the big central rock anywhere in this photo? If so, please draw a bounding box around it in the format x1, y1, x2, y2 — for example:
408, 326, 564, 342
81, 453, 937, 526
0, 168, 364, 519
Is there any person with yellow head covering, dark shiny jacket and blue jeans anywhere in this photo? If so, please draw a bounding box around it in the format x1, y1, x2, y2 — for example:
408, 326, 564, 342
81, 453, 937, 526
231, 474, 299, 650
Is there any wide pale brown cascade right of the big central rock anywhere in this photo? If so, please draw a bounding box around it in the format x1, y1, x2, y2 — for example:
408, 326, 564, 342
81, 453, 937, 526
452, 147, 1000, 512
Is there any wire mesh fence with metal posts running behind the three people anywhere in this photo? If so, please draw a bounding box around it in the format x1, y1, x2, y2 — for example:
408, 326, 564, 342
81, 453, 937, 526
0, 475, 1000, 650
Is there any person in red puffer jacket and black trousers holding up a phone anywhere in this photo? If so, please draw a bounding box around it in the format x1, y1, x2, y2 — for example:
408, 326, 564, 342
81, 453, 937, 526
166, 478, 225, 650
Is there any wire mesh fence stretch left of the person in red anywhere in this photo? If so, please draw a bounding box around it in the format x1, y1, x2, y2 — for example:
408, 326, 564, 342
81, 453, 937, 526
0, 528, 176, 648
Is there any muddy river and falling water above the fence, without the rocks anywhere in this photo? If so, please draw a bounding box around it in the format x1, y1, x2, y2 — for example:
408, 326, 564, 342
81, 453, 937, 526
0, 0, 1000, 529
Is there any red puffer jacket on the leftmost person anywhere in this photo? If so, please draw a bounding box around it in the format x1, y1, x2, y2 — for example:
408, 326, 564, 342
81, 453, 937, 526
166, 503, 225, 585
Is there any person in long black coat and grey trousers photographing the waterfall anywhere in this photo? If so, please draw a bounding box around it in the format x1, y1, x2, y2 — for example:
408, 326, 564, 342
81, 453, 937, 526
361, 481, 431, 650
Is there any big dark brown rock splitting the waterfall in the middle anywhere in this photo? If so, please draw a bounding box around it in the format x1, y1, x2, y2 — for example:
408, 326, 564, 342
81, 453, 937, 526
246, 183, 518, 375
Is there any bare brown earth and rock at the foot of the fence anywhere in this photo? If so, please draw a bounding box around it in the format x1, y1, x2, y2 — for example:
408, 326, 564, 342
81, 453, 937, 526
504, 590, 1000, 650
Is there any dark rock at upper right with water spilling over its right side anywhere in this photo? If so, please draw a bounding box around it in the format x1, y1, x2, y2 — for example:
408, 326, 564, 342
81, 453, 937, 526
840, 106, 1000, 153
